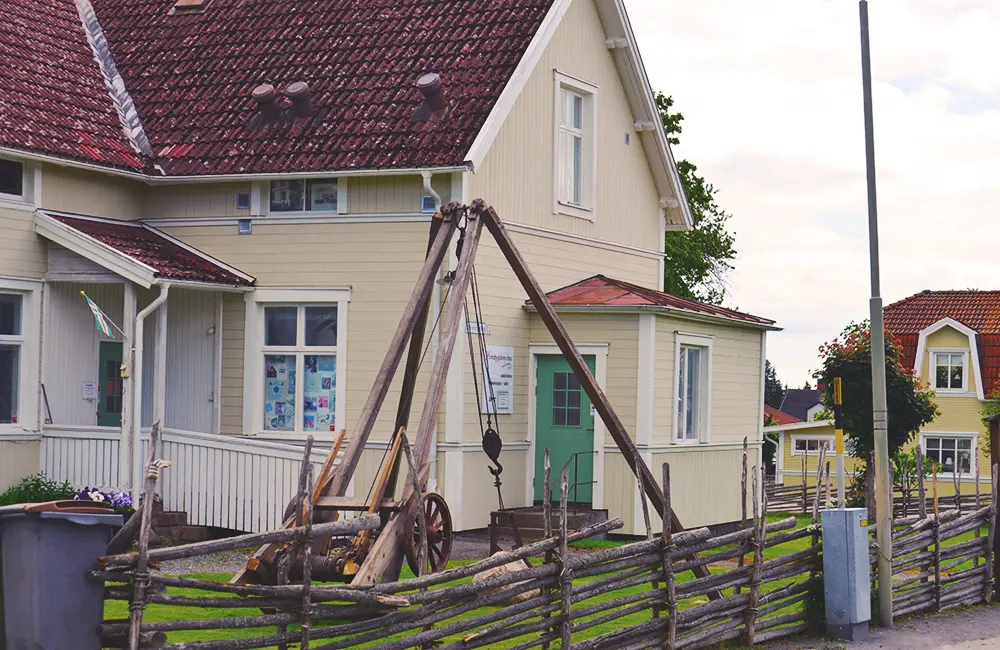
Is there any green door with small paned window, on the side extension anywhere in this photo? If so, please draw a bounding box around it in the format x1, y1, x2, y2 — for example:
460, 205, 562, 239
535, 355, 594, 504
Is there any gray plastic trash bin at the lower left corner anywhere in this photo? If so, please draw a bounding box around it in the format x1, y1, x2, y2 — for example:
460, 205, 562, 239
0, 508, 122, 650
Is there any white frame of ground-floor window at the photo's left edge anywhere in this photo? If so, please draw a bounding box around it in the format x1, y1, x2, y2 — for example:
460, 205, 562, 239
0, 277, 44, 435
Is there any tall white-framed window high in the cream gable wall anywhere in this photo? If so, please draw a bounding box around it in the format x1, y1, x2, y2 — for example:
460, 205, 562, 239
553, 71, 597, 219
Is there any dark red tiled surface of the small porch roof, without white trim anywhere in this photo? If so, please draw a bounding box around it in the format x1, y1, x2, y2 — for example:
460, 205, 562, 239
50, 214, 253, 286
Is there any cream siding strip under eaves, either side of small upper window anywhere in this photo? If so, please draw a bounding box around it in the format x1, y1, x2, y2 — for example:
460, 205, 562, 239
144, 174, 451, 220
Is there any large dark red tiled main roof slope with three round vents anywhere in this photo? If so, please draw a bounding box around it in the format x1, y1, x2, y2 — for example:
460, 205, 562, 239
82, 0, 552, 175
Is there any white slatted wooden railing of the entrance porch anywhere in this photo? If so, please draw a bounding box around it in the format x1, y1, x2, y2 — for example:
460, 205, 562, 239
41, 426, 340, 532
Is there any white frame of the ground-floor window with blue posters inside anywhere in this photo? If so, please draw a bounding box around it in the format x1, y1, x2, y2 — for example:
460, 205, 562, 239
243, 288, 351, 440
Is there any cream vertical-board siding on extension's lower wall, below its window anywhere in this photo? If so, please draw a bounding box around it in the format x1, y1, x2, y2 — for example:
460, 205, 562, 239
656, 445, 760, 530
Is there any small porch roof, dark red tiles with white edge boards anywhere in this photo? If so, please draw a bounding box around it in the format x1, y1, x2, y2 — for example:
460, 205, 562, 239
35, 210, 255, 288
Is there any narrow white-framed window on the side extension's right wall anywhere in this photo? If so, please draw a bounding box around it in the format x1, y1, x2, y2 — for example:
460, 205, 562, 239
674, 332, 712, 443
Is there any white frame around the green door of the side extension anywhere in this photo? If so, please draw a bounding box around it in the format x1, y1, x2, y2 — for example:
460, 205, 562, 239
524, 343, 608, 509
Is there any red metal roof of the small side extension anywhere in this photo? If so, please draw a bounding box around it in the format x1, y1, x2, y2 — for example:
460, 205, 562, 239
548, 275, 774, 325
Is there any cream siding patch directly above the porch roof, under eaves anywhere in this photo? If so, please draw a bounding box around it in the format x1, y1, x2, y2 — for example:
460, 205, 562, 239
39, 165, 146, 220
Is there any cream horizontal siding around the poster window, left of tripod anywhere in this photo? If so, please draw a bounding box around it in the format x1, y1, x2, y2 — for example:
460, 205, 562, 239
154, 222, 430, 489
